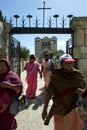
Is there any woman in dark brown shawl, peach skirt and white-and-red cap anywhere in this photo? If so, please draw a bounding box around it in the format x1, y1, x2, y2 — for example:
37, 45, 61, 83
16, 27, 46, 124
42, 54, 86, 130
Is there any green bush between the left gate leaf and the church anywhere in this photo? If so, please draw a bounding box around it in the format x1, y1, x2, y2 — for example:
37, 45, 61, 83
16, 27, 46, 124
20, 46, 30, 60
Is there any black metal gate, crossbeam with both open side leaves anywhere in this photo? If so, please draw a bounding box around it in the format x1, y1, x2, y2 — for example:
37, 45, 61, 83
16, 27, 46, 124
9, 19, 74, 74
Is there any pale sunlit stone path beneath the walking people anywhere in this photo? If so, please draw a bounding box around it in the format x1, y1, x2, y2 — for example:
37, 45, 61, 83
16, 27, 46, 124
16, 71, 53, 130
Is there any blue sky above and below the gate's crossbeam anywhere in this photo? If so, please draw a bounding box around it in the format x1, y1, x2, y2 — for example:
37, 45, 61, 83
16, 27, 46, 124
0, 0, 87, 54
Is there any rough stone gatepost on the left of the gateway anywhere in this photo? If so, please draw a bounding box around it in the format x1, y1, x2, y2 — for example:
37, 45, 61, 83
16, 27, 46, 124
0, 21, 11, 59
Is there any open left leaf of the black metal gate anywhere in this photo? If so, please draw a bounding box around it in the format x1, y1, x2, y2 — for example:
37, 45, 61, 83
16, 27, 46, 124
9, 37, 20, 76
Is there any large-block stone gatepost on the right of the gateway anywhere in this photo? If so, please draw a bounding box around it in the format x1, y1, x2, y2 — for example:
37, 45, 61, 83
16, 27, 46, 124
70, 17, 87, 81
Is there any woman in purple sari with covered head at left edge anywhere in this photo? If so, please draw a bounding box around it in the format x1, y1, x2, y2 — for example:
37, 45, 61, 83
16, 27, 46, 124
0, 59, 23, 130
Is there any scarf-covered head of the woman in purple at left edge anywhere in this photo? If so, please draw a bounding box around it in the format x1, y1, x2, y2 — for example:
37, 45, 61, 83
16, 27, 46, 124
0, 59, 11, 73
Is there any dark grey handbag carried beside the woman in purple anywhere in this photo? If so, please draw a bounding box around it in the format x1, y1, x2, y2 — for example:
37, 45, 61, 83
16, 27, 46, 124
10, 95, 28, 116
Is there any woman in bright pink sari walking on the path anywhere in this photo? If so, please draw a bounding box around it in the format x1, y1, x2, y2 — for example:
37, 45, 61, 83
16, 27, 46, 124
24, 54, 42, 98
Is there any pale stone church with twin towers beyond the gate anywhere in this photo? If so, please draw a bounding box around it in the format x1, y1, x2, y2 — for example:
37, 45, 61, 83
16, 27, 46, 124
35, 36, 57, 58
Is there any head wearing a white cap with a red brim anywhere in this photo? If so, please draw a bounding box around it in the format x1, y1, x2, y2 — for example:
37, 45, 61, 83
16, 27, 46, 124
59, 54, 75, 70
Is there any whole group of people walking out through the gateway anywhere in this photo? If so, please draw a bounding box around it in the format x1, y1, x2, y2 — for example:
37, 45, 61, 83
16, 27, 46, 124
0, 53, 87, 130
